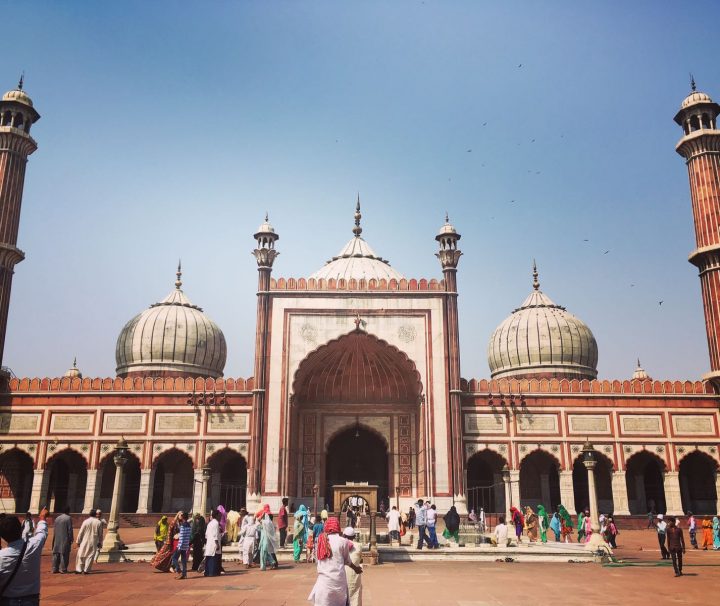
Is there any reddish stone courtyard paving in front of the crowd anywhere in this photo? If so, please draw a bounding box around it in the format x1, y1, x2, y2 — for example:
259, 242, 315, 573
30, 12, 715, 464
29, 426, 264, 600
42, 529, 720, 606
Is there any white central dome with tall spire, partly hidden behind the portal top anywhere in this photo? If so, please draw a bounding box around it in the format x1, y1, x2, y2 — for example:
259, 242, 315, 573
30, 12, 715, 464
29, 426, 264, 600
310, 196, 405, 280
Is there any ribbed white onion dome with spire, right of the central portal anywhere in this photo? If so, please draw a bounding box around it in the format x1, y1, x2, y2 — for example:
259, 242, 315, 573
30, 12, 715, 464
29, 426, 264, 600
488, 263, 598, 379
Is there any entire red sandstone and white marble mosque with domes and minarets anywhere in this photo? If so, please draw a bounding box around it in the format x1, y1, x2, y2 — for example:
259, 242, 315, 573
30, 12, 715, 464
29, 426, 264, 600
0, 82, 720, 516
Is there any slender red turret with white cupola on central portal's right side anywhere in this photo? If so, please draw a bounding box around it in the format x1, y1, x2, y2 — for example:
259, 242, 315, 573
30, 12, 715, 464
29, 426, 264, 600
435, 214, 467, 513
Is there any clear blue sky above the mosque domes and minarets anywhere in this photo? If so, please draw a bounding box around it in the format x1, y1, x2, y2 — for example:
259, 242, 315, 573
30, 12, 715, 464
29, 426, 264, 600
0, 0, 720, 379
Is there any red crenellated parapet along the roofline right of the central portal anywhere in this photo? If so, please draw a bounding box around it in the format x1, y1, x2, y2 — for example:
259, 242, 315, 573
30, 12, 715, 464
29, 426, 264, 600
460, 379, 715, 396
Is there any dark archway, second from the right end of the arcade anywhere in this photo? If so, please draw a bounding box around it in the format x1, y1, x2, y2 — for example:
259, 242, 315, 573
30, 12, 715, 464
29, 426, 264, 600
625, 450, 666, 515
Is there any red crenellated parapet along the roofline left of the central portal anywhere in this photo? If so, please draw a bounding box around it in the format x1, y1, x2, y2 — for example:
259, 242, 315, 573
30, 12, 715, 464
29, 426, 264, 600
9, 377, 255, 393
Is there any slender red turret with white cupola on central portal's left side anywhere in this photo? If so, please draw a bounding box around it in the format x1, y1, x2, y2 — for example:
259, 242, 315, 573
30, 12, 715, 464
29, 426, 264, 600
247, 213, 280, 511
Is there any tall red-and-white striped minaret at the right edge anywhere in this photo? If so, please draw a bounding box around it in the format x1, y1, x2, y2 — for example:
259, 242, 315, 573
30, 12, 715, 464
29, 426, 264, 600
675, 79, 720, 389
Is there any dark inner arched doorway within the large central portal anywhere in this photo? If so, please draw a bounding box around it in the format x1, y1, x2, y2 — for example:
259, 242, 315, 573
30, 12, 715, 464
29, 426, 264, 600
325, 425, 390, 507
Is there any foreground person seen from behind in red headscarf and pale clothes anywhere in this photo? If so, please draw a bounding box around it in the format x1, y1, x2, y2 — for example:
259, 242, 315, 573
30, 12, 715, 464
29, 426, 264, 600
308, 516, 362, 606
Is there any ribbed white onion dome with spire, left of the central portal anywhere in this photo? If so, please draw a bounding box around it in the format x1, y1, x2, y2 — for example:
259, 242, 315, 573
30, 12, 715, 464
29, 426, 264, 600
115, 265, 227, 378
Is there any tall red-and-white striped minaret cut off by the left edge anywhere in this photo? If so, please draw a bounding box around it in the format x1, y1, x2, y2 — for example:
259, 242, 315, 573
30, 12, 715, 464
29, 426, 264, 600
0, 78, 40, 378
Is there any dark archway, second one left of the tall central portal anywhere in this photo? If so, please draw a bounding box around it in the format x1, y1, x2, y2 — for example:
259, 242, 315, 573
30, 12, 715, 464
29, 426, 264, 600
152, 448, 194, 513
